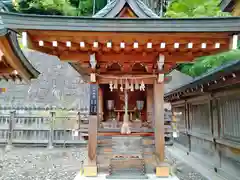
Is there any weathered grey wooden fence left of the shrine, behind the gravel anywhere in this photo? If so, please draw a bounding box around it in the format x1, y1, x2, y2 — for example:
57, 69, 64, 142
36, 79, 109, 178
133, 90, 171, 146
0, 111, 88, 147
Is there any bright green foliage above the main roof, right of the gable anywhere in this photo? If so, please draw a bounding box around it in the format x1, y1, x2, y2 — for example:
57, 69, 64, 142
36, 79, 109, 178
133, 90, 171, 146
165, 0, 230, 18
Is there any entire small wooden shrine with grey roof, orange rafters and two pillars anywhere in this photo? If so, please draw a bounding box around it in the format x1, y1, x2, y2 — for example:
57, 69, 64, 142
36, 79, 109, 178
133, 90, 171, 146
0, 0, 240, 179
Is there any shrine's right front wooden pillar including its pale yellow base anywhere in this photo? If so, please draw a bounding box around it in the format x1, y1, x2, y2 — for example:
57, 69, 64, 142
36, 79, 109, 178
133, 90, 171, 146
153, 81, 169, 177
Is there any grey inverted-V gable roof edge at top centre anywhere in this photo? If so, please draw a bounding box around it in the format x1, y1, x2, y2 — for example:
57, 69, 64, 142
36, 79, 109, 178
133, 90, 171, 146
93, 0, 159, 18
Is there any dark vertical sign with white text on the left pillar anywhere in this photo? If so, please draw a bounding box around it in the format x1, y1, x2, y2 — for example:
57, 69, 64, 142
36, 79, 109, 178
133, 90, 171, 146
90, 84, 98, 115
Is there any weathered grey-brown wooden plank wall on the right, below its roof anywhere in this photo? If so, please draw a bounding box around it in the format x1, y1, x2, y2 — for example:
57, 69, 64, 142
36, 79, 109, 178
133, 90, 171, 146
172, 89, 240, 180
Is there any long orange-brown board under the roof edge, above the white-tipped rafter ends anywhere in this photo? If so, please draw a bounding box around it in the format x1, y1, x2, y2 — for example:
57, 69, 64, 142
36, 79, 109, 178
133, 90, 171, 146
28, 30, 229, 44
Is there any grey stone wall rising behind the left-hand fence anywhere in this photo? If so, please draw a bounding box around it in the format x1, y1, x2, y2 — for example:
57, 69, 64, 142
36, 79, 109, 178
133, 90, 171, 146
0, 50, 89, 109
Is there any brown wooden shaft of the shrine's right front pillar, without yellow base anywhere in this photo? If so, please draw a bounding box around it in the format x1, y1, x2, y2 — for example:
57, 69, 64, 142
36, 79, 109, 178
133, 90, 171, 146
153, 80, 165, 163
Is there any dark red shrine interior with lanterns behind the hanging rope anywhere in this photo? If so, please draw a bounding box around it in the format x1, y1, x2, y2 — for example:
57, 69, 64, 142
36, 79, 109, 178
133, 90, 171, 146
100, 84, 148, 129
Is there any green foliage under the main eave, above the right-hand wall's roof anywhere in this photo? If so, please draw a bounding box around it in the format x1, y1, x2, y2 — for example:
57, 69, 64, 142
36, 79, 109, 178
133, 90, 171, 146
180, 50, 240, 77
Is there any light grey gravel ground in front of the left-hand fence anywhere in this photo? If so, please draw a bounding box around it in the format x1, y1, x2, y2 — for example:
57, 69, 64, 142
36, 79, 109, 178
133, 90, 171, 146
0, 147, 86, 180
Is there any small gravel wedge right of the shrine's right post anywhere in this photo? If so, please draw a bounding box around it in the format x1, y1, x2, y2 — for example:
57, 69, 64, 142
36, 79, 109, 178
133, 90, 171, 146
166, 152, 208, 180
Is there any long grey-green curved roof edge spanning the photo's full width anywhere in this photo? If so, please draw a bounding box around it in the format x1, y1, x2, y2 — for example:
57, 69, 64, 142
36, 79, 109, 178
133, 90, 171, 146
0, 12, 240, 33
